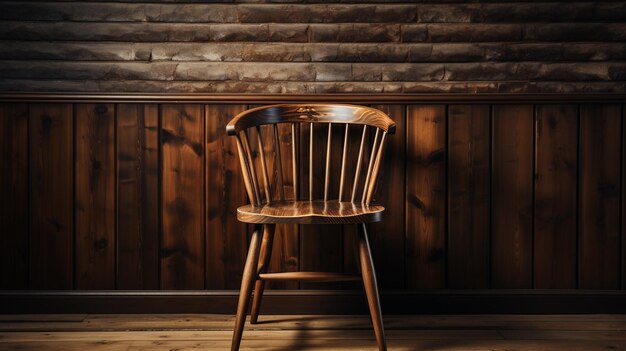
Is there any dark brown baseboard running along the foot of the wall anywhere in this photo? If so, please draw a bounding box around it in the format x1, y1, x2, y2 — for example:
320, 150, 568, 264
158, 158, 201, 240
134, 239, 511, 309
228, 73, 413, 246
0, 290, 626, 314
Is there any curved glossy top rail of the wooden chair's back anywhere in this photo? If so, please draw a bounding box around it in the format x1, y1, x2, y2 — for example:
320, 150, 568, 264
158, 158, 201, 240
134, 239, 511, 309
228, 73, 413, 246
226, 104, 396, 135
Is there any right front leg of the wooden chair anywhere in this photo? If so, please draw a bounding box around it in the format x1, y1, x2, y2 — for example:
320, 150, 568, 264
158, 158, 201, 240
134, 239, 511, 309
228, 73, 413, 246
357, 223, 387, 351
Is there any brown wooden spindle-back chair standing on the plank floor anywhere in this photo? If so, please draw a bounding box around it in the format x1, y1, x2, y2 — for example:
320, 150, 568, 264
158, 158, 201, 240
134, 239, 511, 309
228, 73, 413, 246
226, 104, 395, 350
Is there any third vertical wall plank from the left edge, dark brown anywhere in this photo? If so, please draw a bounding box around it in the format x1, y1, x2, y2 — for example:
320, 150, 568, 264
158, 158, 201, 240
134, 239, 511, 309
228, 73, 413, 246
74, 104, 116, 290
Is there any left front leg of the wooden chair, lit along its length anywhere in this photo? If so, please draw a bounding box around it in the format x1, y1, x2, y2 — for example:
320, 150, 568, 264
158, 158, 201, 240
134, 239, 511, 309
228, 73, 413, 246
230, 225, 263, 351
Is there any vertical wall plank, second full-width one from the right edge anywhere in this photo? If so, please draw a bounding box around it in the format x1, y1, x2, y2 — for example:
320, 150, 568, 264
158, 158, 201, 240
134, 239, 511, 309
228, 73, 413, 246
533, 105, 578, 289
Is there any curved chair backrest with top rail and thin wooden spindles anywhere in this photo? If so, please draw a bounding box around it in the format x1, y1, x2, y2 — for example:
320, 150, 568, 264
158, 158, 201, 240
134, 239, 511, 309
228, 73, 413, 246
226, 104, 395, 206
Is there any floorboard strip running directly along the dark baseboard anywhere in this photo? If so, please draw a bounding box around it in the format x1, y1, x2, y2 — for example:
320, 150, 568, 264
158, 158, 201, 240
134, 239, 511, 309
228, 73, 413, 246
6, 314, 626, 332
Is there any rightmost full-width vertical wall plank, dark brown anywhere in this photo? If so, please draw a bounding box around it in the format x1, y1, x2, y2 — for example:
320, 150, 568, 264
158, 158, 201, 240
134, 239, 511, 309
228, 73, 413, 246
579, 104, 621, 289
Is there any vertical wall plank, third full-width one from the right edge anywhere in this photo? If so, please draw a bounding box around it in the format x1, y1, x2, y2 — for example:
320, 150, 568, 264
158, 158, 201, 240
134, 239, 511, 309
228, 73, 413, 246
491, 105, 533, 289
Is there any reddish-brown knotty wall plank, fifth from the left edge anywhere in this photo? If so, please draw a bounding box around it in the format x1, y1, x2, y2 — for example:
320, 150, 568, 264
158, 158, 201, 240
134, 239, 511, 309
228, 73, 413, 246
160, 104, 205, 289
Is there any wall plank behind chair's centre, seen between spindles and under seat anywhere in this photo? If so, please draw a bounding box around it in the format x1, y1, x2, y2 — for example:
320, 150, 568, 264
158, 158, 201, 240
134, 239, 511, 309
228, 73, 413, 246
299, 123, 343, 289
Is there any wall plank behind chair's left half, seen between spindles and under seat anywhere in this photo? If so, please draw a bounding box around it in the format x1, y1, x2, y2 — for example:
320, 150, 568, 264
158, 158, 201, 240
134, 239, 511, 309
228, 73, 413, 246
263, 124, 300, 289
